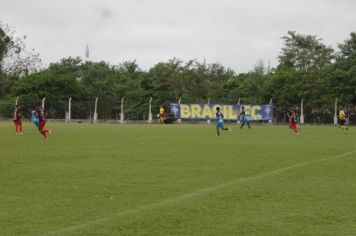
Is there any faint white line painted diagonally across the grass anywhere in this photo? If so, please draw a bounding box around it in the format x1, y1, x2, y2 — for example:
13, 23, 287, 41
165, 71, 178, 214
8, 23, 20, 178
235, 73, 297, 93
44, 150, 356, 235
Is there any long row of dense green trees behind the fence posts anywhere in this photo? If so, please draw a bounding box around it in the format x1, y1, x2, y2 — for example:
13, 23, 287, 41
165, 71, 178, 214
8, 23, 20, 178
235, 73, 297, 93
0, 24, 356, 121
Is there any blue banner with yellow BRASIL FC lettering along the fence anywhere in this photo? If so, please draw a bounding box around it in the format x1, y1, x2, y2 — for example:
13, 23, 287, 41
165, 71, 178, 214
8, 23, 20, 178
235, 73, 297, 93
170, 103, 273, 121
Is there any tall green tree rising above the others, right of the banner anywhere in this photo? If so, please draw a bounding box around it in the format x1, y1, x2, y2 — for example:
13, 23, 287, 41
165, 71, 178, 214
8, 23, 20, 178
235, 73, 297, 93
268, 31, 334, 119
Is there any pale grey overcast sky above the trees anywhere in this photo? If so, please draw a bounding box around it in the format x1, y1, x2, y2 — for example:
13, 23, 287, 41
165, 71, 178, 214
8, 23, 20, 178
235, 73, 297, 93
0, 0, 356, 72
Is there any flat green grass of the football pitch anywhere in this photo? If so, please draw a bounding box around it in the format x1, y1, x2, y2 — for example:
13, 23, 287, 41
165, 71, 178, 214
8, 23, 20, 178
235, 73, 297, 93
0, 122, 356, 235
